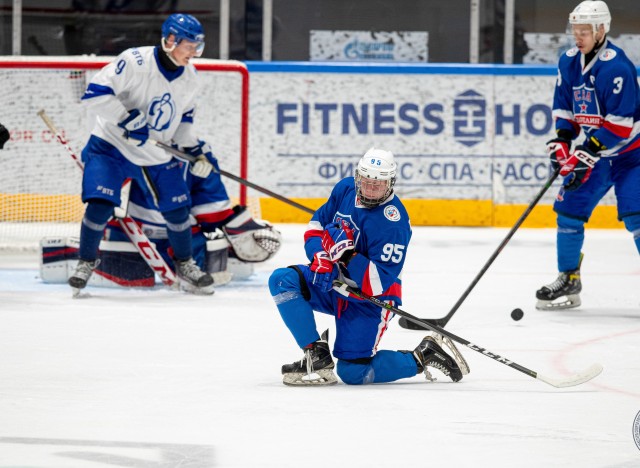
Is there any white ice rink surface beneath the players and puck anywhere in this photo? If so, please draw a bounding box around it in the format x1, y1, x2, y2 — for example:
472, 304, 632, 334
0, 225, 640, 468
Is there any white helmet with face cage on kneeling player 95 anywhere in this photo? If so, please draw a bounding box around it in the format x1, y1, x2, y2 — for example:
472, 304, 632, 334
355, 148, 398, 208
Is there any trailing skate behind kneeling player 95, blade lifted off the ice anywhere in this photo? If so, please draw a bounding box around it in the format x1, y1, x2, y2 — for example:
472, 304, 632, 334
413, 335, 469, 382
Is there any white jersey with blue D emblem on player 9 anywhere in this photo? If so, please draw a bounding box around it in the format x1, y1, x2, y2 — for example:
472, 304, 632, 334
82, 46, 198, 166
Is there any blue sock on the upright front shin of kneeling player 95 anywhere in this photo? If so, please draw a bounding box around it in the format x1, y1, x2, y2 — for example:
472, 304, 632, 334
269, 268, 320, 348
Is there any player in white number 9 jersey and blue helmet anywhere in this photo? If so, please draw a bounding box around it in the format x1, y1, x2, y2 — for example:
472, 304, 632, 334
69, 14, 213, 294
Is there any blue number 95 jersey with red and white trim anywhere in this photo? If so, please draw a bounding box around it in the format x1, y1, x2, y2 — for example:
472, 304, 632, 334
305, 177, 411, 304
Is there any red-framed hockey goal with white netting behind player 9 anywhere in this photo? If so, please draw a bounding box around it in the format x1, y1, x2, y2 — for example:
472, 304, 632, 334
0, 57, 254, 250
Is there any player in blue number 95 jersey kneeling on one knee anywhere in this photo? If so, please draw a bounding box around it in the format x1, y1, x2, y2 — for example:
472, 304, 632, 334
269, 148, 469, 386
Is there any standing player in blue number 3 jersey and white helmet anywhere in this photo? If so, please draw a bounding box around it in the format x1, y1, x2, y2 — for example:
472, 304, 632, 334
536, 1, 640, 309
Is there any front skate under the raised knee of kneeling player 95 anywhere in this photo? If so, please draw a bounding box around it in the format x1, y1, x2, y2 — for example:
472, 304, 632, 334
282, 330, 338, 387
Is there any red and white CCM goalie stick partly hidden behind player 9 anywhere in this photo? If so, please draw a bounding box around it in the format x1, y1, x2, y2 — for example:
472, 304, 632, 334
38, 109, 176, 286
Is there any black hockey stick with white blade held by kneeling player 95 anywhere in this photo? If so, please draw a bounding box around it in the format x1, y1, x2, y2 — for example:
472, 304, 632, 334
333, 280, 603, 388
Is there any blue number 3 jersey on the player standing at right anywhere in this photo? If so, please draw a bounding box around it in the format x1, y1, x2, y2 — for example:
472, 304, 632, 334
553, 40, 640, 156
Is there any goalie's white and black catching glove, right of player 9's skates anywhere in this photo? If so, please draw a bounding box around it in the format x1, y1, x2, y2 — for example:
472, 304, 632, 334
222, 206, 282, 262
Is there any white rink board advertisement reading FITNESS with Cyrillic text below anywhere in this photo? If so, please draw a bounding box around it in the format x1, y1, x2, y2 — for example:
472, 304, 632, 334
250, 66, 613, 210
